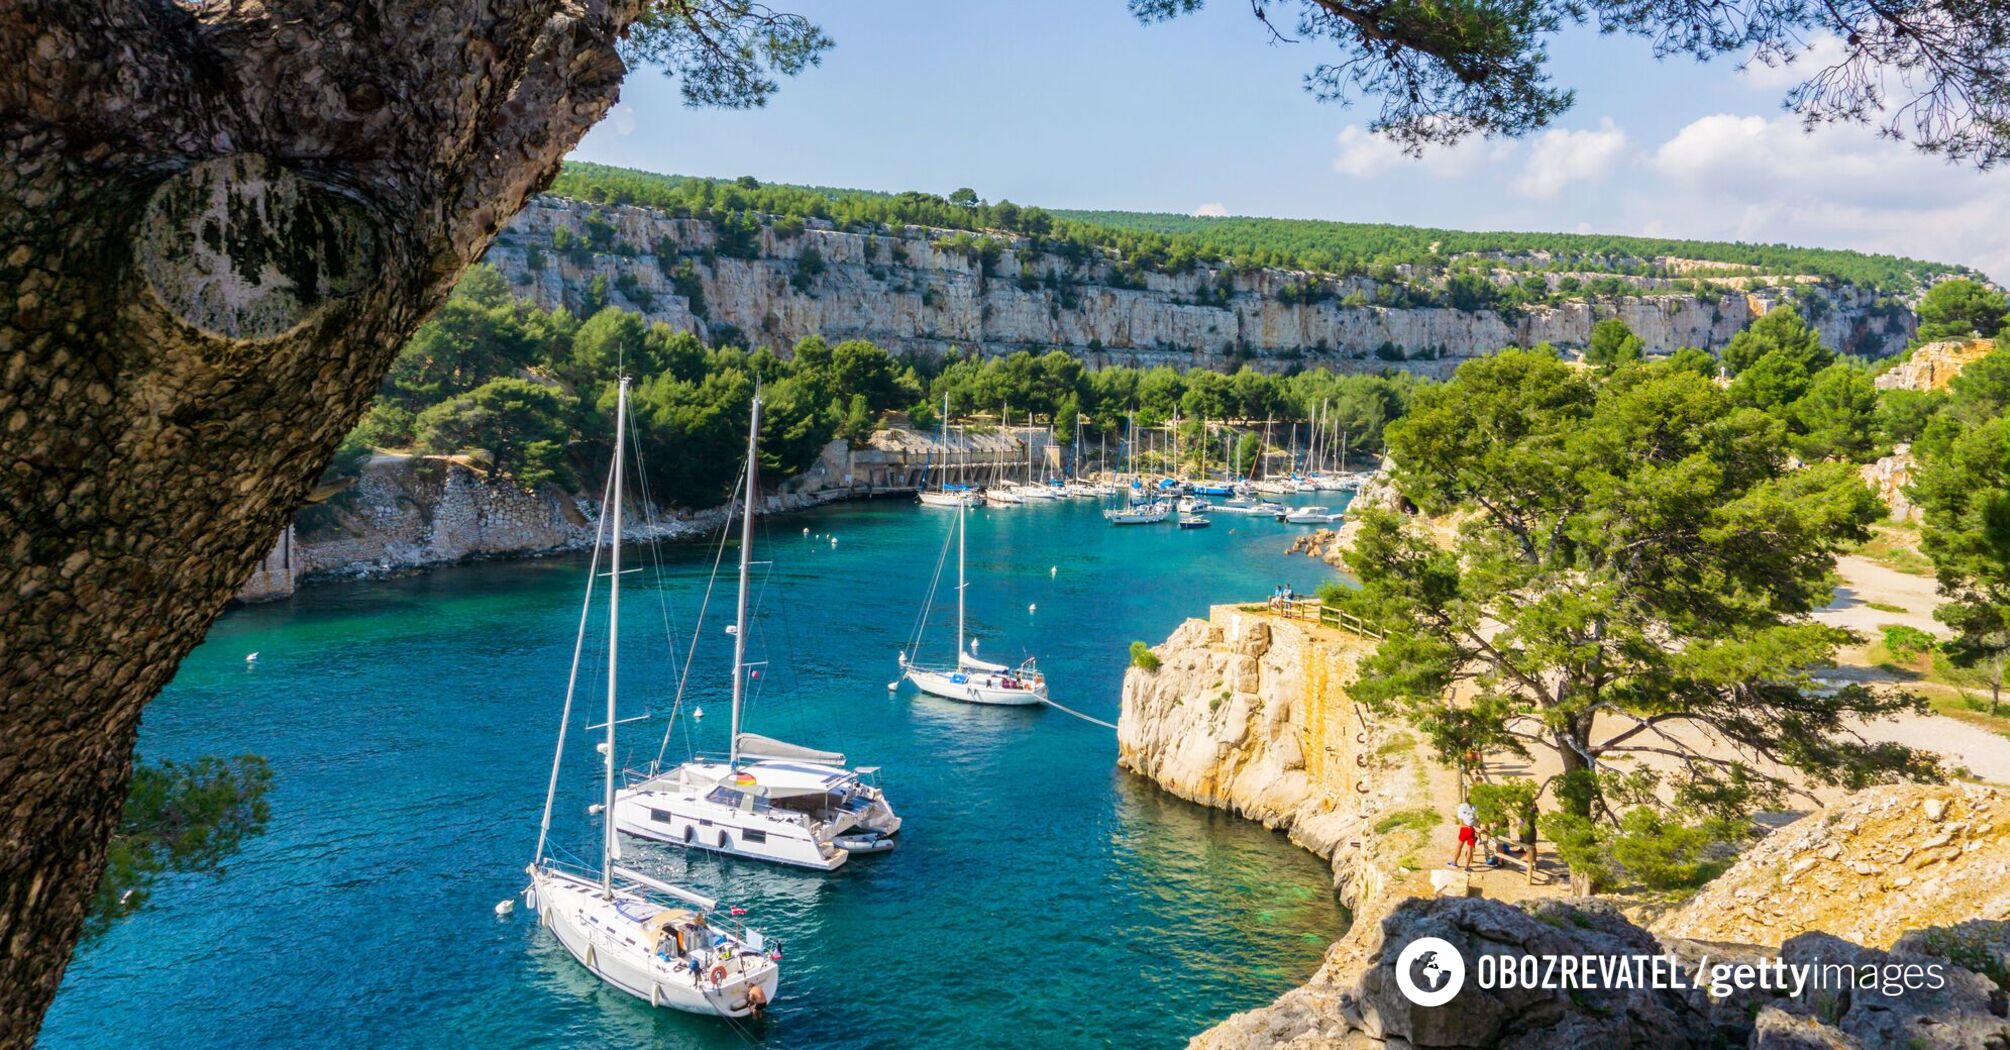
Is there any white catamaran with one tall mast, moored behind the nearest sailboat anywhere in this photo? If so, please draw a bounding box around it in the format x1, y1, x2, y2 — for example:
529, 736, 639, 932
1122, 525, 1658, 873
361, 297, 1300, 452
613, 394, 900, 871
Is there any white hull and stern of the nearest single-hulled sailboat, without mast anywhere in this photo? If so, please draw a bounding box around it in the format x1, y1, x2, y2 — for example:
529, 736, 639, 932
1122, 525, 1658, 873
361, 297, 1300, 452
531, 867, 782, 1018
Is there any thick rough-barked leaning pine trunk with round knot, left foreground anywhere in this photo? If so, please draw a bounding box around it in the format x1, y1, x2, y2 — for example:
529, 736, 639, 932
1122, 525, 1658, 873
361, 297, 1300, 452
0, 0, 633, 1046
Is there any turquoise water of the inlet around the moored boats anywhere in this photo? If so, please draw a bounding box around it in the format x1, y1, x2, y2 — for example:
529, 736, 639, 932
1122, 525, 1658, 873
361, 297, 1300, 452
42, 493, 1345, 1048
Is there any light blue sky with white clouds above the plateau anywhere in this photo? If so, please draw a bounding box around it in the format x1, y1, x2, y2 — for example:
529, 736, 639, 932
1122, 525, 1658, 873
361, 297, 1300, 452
575, 0, 2010, 278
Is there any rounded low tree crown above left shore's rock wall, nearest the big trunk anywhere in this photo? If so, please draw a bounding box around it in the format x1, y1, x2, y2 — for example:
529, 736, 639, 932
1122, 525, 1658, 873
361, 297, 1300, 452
414, 378, 571, 489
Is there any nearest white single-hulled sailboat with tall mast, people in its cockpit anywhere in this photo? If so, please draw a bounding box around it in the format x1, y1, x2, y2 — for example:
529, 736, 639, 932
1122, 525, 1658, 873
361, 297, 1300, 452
523, 376, 782, 1018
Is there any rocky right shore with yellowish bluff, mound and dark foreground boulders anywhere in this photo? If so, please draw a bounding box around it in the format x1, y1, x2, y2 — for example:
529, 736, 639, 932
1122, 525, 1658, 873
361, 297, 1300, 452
1118, 605, 2010, 1050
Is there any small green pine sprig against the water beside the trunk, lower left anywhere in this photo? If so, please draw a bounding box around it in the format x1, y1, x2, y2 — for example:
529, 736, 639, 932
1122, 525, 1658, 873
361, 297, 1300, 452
84, 754, 271, 937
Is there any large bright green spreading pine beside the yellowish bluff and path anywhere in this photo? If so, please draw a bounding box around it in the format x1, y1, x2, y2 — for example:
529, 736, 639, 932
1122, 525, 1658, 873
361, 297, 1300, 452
1343, 350, 1932, 832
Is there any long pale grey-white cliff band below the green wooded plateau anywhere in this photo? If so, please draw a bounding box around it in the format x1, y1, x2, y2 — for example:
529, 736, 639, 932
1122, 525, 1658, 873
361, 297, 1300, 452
488, 197, 1914, 374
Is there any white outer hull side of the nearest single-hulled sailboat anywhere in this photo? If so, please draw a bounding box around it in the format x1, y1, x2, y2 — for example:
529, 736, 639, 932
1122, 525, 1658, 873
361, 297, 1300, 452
531, 871, 782, 1018
